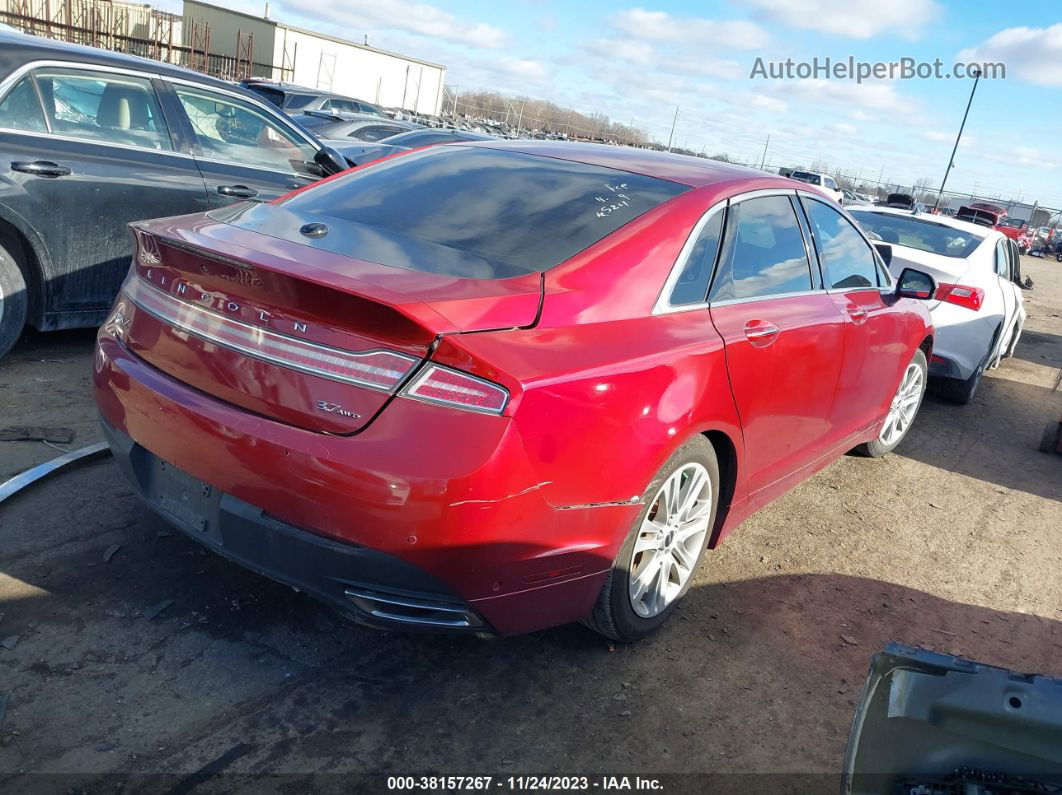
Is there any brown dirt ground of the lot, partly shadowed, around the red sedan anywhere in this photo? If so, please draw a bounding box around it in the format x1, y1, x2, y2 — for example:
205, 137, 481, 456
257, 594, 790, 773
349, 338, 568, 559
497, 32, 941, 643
0, 258, 1062, 792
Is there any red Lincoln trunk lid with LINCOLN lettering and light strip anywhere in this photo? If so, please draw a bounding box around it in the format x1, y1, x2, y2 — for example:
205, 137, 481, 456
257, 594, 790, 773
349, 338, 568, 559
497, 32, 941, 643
120, 212, 542, 434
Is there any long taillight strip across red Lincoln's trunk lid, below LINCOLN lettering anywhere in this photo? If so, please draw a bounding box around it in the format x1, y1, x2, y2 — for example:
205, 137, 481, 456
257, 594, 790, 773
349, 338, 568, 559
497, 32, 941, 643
125, 277, 419, 393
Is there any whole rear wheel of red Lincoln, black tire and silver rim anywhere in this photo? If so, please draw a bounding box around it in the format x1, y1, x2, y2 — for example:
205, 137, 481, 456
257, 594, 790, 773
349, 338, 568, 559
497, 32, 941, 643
584, 436, 719, 642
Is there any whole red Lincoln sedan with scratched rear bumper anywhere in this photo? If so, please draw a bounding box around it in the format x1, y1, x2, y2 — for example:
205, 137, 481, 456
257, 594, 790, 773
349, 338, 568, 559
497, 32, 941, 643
95, 141, 936, 640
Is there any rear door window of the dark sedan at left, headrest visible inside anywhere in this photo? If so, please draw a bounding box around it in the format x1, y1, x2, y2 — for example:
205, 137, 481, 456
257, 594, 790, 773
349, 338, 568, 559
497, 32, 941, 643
34, 69, 173, 150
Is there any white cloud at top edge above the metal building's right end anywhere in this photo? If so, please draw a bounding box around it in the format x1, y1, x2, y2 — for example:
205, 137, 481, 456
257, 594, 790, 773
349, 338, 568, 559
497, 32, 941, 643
282, 0, 508, 50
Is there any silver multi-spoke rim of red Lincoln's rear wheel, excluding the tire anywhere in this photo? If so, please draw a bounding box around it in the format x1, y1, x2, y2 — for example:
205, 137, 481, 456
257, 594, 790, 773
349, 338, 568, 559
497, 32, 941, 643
629, 462, 713, 619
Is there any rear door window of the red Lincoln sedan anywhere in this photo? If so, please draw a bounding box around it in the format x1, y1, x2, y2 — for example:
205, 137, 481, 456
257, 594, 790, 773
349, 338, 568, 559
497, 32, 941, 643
712, 196, 811, 301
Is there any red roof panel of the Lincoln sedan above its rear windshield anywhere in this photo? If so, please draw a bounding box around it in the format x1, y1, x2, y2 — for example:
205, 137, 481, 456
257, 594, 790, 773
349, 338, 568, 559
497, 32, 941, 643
449, 139, 790, 189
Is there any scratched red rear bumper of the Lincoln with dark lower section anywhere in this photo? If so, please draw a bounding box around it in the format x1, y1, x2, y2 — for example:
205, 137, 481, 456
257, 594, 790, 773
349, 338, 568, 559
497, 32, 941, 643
93, 332, 639, 635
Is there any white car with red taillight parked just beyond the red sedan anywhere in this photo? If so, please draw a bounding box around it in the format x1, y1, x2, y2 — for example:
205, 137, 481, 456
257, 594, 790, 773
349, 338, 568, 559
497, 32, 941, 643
850, 207, 1026, 403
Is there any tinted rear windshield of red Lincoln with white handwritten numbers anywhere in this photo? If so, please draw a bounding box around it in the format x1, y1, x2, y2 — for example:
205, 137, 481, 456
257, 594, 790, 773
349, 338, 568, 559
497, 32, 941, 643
259, 145, 689, 279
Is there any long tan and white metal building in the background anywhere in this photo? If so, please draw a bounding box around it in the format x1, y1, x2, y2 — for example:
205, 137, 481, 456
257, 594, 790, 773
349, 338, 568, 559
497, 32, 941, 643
184, 0, 446, 115
